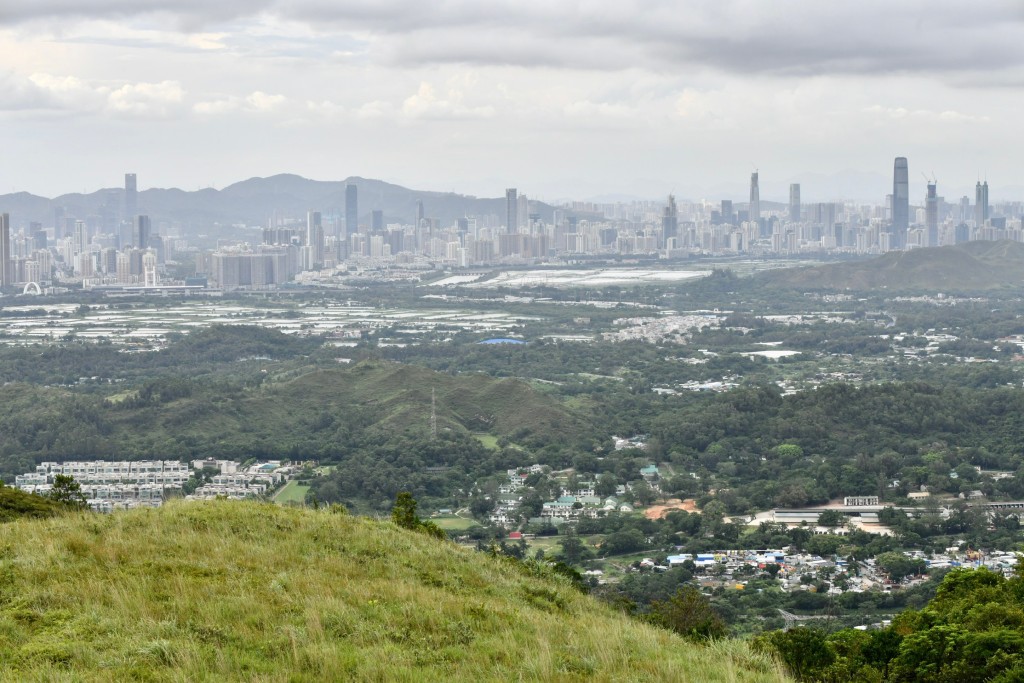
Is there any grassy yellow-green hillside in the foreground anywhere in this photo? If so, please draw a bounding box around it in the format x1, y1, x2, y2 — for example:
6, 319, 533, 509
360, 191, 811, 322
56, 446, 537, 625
0, 502, 783, 681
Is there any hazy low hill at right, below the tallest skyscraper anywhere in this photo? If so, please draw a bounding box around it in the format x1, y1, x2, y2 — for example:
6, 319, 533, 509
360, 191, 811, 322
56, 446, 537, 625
758, 241, 1024, 292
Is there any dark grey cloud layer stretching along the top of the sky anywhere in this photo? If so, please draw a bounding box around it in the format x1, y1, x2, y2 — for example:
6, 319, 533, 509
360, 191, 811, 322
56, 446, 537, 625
0, 0, 1024, 85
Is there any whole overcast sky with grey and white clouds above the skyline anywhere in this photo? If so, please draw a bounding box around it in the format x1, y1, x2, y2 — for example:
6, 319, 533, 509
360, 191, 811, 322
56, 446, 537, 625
0, 0, 1024, 202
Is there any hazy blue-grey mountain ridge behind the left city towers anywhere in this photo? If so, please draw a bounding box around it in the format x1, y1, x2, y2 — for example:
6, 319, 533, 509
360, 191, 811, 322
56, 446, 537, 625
0, 174, 554, 233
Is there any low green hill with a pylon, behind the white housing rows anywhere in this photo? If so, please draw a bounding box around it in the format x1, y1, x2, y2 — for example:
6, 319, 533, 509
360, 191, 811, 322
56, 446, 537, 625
0, 361, 592, 477
